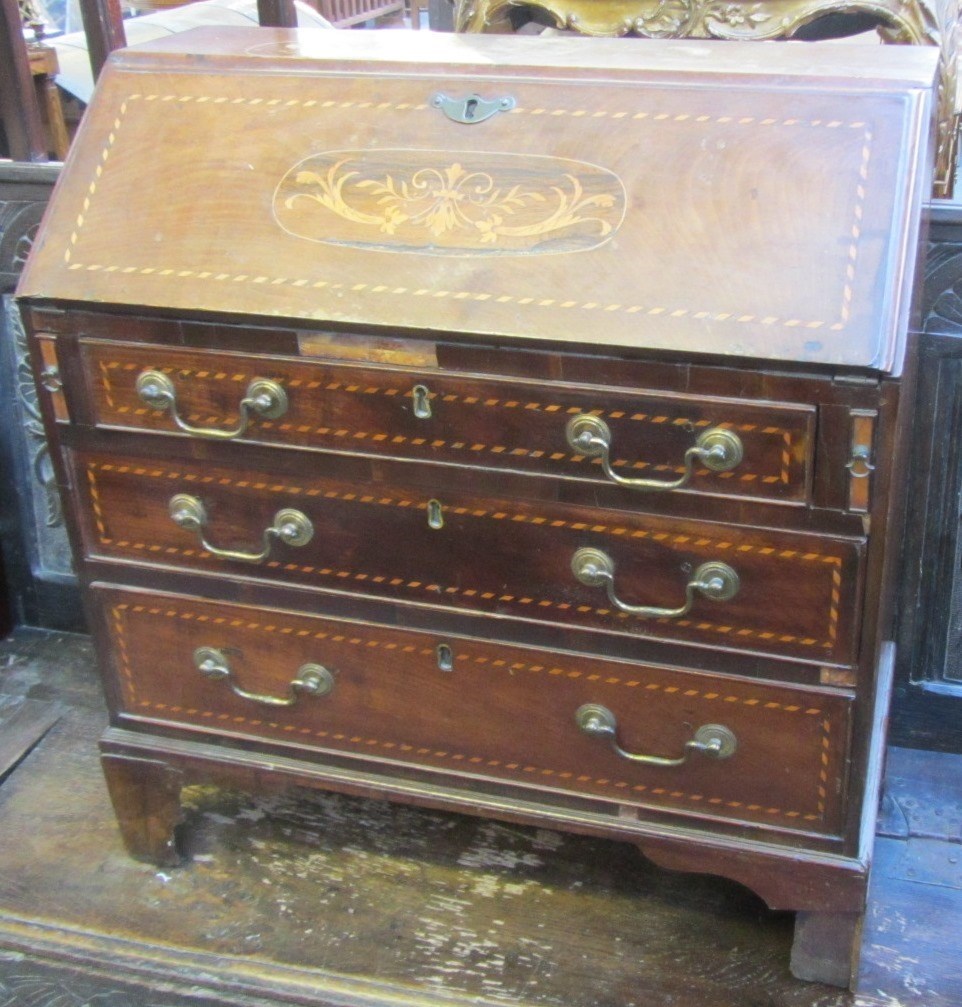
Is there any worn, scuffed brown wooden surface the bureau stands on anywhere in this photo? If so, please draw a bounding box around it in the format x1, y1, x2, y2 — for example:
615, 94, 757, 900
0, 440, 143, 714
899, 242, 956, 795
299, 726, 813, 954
0, 636, 962, 1007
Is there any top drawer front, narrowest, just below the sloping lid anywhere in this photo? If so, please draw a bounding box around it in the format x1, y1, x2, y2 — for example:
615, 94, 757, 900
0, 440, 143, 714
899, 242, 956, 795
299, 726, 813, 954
83, 341, 815, 504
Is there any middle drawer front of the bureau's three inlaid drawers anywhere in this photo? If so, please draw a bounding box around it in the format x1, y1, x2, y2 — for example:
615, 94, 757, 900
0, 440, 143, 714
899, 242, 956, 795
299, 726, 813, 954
76, 454, 862, 665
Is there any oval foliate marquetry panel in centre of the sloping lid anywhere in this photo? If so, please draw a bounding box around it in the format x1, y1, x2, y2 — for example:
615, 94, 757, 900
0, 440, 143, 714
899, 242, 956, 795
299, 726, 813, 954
274, 150, 626, 255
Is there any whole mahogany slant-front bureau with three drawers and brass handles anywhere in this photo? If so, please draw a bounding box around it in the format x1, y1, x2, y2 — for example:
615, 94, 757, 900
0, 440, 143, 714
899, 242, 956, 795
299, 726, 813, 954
19, 30, 935, 984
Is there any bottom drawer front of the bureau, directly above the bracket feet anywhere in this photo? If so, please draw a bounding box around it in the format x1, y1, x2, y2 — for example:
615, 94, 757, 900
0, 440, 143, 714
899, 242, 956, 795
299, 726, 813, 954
94, 588, 850, 833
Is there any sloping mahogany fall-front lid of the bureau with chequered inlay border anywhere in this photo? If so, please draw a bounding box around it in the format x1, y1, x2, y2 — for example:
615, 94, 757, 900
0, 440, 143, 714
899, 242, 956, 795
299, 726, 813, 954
20, 32, 934, 373
